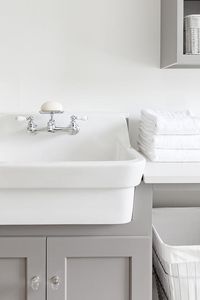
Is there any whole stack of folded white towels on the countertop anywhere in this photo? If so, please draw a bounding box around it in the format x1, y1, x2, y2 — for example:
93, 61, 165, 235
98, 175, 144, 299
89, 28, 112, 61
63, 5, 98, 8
138, 110, 200, 162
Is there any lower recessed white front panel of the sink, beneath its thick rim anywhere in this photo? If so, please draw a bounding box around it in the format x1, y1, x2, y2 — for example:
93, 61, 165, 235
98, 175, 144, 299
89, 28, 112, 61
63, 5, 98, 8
0, 188, 134, 225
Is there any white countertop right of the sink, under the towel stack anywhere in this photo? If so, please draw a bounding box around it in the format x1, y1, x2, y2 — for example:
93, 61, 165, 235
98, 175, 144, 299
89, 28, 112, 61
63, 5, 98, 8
143, 161, 200, 183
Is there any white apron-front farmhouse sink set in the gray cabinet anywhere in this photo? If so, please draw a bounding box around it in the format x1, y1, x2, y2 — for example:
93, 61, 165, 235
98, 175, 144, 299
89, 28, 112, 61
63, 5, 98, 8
0, 114, 145, 225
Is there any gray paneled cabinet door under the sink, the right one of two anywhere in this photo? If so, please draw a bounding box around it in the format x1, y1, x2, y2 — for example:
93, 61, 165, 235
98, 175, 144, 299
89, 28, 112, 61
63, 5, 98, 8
47, 237, 152, 300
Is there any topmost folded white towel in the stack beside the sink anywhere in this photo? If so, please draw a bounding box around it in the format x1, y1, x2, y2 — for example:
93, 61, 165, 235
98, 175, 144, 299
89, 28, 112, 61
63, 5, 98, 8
140, 110, 200, 135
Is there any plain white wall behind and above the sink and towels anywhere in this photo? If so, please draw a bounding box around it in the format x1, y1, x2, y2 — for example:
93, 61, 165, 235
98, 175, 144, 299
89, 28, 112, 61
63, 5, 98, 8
0, 0, 200, 124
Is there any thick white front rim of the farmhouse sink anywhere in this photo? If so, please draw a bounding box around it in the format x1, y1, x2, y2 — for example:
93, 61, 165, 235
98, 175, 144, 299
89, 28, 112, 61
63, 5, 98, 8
0, 148, 146, 189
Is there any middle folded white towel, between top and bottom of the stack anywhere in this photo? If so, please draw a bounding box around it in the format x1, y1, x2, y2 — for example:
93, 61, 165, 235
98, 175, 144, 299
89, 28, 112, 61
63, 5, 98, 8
138, 130, 200, 150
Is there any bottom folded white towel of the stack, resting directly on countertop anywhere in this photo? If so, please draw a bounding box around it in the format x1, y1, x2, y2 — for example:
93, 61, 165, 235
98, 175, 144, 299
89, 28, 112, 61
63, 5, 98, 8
139, 146, 200, 162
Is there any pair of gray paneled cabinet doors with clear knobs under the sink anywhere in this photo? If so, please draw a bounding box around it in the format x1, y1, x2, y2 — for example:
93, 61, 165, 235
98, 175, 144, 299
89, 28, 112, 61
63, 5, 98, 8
0, 236, 151, 300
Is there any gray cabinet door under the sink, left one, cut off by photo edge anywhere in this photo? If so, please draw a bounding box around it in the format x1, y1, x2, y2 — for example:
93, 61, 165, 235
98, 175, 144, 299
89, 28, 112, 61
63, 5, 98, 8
0, 237, 46, 300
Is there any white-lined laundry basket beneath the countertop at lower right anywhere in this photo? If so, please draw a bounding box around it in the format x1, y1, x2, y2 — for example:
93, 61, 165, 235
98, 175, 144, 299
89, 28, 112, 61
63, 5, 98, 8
153, 208, 200, 300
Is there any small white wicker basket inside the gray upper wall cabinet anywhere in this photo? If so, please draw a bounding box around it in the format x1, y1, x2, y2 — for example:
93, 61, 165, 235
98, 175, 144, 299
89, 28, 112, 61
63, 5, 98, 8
184, 15, 200, 55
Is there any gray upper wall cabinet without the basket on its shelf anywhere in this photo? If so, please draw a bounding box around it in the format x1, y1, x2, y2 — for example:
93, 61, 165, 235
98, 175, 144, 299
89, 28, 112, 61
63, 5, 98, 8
161, 0, 200, 68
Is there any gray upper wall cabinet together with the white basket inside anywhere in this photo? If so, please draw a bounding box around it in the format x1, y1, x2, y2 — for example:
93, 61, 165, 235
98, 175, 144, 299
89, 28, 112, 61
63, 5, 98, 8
161, 0, 200, 68
